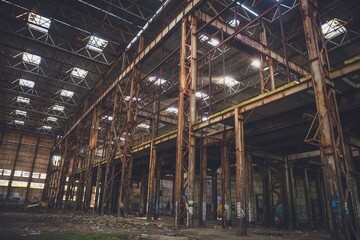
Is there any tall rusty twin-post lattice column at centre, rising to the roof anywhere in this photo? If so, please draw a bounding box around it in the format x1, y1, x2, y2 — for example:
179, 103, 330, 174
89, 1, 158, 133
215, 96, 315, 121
174, 16, 197, 229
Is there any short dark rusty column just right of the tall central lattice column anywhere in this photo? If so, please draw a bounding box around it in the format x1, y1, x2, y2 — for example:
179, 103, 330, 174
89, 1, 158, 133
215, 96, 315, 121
199, 146, 207, 227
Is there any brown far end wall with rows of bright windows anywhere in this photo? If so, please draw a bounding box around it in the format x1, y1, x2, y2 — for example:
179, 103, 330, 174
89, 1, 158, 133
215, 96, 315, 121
0, 129, 54, 201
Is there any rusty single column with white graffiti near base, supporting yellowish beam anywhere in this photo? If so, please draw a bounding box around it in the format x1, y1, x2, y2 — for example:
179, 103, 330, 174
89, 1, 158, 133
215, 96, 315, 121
234, 108, 248, 236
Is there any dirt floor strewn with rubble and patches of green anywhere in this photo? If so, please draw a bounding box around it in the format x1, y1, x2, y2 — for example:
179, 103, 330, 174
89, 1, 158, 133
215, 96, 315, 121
0, 204, 330, 240
